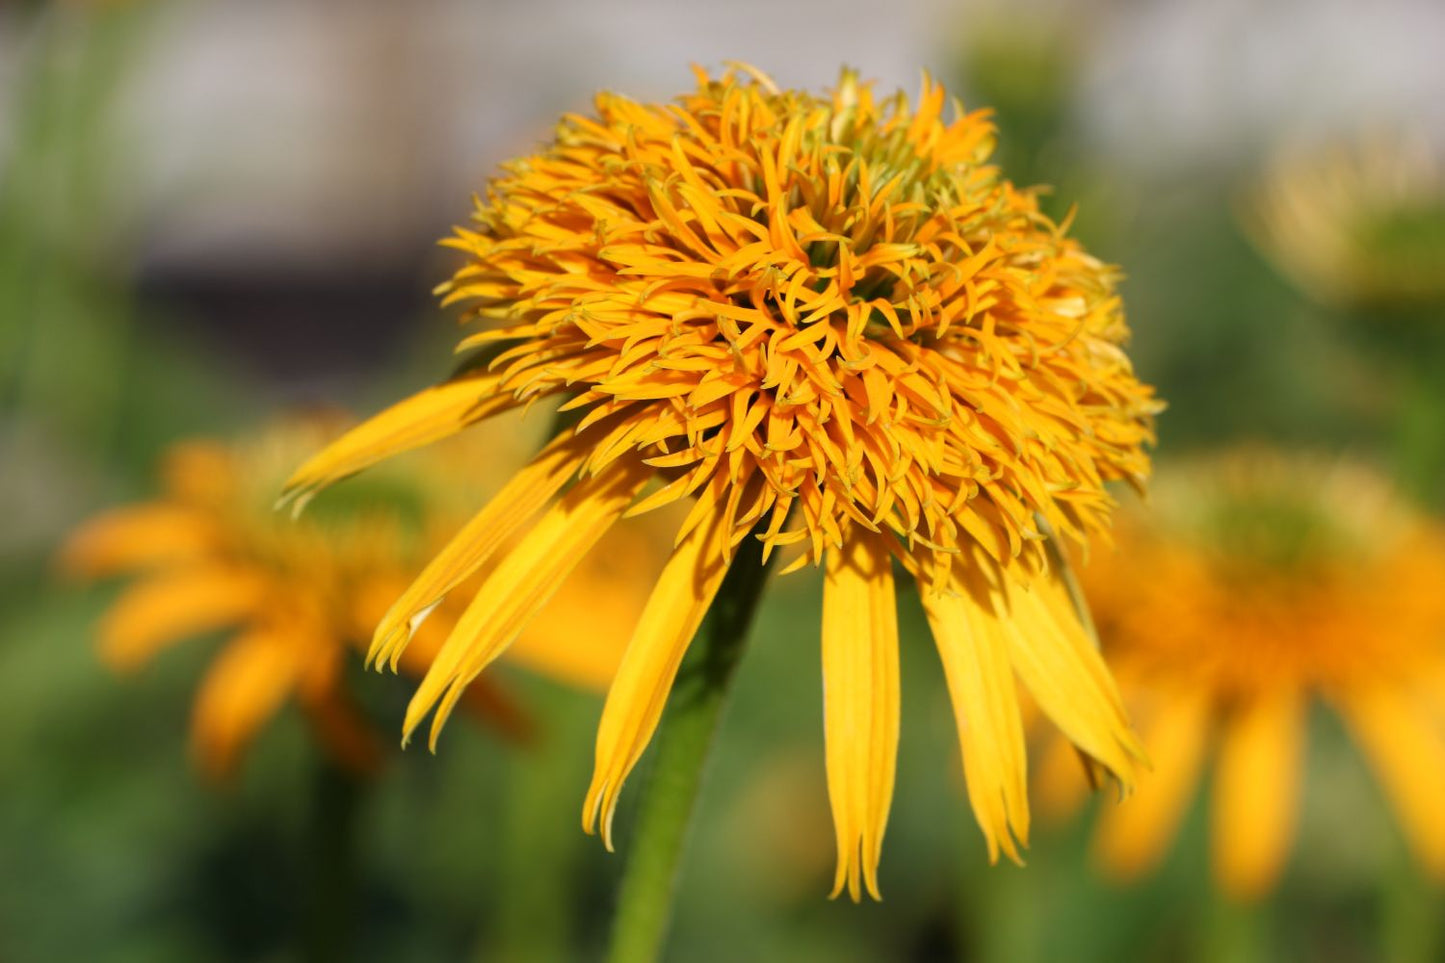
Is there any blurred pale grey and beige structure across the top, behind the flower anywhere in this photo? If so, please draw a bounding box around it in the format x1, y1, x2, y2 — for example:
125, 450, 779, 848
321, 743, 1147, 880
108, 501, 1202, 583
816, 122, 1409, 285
0, 0, 1445, 272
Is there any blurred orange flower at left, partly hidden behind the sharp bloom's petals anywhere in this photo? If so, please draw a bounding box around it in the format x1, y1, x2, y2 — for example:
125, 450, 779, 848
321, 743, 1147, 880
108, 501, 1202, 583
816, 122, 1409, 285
62, 419, 659, 778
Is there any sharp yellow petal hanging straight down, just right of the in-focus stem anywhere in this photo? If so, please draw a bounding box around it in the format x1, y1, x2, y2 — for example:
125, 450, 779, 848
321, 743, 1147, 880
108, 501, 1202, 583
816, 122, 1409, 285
822, 528, 899, 902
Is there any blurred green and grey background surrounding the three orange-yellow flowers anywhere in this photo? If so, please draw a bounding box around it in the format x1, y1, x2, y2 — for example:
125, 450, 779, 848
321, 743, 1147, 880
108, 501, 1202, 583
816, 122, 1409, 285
8, 0, 1445, 963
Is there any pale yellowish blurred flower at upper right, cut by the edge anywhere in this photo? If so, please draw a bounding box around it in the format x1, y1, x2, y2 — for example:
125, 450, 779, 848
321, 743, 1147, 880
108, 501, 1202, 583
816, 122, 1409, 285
1243, 133, 1445, 307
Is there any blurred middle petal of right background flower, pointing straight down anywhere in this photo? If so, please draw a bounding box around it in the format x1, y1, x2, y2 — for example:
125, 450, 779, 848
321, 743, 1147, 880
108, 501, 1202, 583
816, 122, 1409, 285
1212, 690, 1305, 899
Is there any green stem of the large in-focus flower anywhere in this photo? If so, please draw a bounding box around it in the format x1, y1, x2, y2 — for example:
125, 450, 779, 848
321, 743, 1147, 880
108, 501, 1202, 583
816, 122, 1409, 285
607, 535, 767, 963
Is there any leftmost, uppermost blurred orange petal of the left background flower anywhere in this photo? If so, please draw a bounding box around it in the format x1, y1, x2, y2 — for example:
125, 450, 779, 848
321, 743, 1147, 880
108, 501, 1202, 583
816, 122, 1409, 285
59, 502, 221, 578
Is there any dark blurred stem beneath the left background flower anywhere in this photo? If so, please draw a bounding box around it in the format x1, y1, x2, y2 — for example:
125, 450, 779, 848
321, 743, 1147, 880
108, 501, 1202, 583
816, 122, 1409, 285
302, 758, 366, 963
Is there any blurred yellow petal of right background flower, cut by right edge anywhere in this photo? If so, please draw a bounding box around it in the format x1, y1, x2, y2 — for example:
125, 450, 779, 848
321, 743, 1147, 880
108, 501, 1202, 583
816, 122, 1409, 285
1337, 690, 1445, 879
